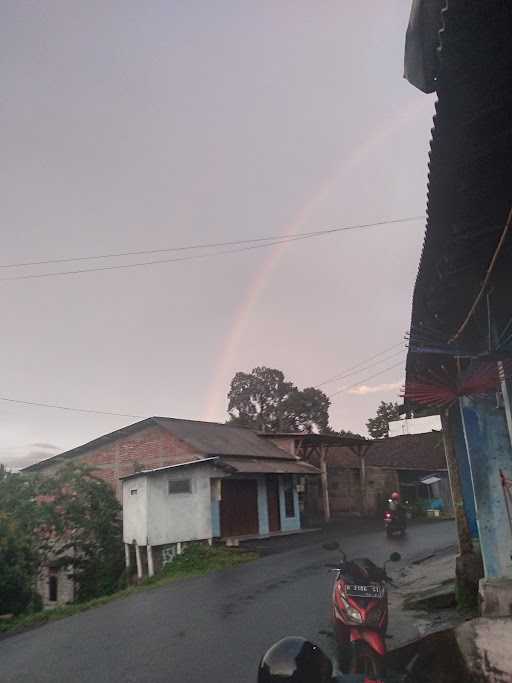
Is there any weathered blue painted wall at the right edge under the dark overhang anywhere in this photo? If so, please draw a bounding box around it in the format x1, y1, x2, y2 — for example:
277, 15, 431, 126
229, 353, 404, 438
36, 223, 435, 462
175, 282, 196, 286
461, 395, 512, 578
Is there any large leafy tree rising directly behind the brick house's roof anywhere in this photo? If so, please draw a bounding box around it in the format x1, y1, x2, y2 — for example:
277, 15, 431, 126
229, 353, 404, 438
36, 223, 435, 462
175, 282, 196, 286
228, 367, 330, 432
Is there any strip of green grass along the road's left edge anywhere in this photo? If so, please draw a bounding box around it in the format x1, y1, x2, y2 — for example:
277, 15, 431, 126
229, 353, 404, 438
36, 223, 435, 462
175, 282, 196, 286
0, 545, 258, 634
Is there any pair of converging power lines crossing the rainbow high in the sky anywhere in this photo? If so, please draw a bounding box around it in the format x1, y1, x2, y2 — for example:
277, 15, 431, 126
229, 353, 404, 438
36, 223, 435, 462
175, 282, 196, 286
0, 216, 424, 281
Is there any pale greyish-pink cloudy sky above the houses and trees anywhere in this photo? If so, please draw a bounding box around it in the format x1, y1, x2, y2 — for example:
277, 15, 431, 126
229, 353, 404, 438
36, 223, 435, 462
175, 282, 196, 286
0, 0, 434, 466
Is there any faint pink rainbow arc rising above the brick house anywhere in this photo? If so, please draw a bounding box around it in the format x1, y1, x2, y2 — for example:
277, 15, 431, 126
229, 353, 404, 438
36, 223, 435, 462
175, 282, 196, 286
204, 95, 433, 421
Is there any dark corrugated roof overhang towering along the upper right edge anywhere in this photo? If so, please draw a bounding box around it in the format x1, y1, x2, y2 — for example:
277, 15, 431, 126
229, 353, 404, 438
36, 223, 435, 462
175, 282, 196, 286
406, 0, 512, 396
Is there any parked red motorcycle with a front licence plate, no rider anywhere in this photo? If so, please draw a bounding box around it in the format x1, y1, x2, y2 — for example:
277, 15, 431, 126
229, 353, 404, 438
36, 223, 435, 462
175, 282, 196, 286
329, 545, 401, 679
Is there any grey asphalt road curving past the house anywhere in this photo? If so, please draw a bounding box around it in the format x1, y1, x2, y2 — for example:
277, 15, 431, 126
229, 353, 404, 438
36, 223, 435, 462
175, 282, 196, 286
0, 522, 455, 683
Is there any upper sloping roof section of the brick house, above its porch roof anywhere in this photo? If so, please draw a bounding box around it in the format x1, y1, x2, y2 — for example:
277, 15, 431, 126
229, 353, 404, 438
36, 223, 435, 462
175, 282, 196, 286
152, 417, 290, 460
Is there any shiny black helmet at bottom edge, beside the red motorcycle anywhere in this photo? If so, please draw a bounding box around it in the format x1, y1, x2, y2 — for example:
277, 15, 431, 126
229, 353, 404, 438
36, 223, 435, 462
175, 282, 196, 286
258, 637, 332, 683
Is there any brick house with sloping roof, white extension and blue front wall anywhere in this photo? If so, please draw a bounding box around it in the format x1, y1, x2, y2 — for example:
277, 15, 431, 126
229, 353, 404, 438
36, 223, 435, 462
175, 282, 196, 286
24, 417, 319, 602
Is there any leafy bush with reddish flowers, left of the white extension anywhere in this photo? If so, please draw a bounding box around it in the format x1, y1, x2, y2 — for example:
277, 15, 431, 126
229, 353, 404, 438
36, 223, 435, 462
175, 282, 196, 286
40, 464, 124, 601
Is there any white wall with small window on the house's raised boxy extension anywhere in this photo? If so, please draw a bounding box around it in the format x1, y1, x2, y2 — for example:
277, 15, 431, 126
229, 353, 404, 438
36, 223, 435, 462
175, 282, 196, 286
147, 464, 219, 545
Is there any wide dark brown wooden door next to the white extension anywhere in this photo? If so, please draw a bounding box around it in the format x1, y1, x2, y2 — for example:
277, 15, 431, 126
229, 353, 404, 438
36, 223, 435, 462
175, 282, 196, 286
220, 479, 259, 537
